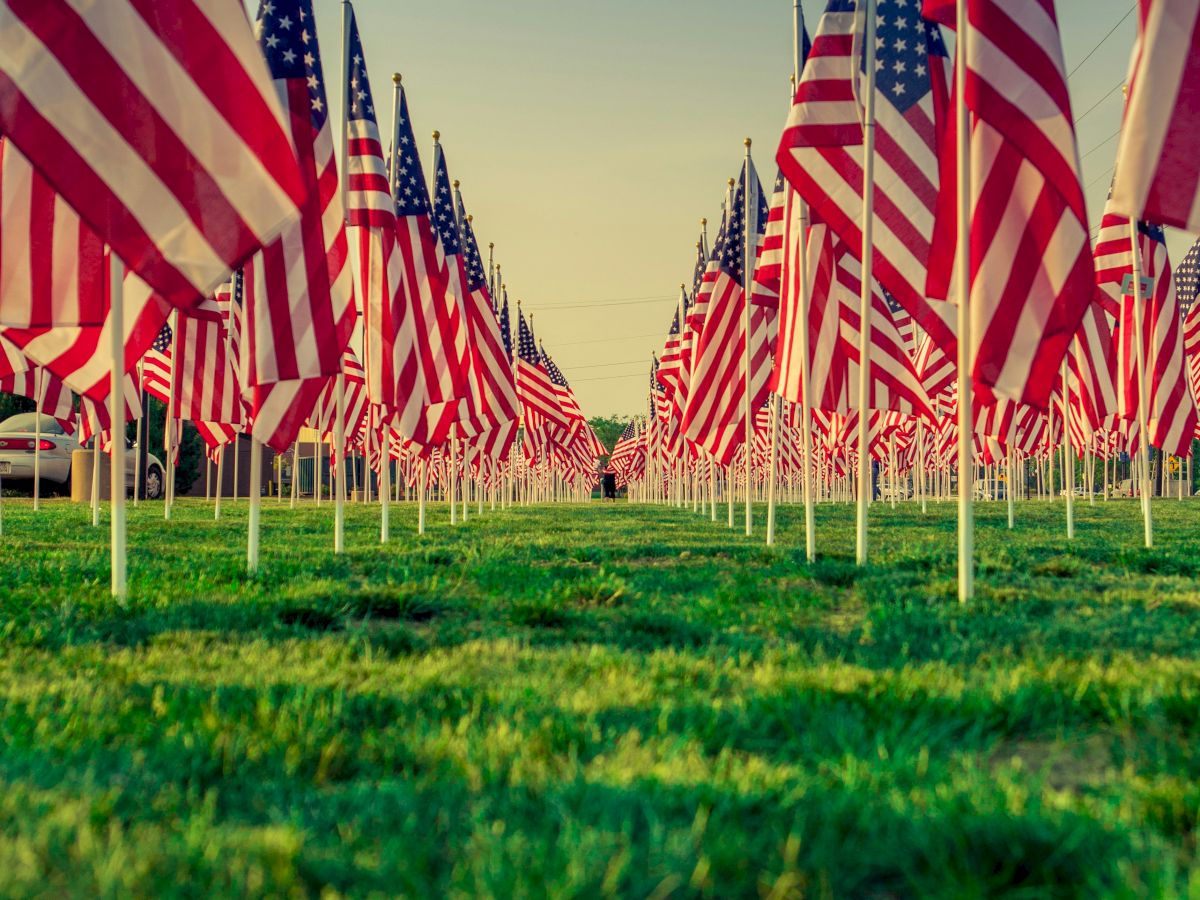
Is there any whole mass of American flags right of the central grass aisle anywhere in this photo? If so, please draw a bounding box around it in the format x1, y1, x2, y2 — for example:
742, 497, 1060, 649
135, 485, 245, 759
611, 0, 1200, 549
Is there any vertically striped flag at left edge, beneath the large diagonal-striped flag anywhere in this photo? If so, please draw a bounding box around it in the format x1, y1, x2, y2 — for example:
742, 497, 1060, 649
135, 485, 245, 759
0, 144, 108, 328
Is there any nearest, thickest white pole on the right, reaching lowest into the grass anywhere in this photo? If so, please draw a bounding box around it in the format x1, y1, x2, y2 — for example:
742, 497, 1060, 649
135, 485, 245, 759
955, 0, 974, 604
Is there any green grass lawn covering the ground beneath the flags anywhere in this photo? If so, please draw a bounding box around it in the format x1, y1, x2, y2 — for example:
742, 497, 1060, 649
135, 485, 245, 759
0, 498, 1200, 898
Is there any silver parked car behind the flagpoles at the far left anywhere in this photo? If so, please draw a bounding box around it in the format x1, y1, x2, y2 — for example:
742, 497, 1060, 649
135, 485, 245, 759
0, 413, 164, 500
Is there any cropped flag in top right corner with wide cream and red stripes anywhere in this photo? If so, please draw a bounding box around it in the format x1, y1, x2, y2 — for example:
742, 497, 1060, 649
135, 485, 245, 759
1112, 0, 1200, 232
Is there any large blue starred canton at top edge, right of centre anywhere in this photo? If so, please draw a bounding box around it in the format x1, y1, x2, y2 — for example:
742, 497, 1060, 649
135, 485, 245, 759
863, 0, 948, 113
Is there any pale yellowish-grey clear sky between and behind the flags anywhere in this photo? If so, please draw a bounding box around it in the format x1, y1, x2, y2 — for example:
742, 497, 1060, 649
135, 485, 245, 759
283, 0, 1190, 415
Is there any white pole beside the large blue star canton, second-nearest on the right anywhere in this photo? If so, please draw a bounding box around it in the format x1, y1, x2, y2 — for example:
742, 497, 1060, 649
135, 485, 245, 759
859, 0, 875, 565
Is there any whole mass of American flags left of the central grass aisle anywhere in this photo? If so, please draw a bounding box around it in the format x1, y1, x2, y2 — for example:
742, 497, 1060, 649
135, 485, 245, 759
0, 0, 605, 511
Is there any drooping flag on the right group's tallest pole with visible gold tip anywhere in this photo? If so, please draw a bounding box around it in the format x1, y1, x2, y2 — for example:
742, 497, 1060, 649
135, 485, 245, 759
683, 158, 770, 466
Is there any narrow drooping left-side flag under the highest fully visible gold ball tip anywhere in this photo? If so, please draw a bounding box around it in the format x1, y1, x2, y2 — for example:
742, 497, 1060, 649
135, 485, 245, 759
391, 88, 467, 446
